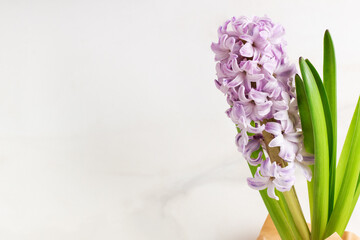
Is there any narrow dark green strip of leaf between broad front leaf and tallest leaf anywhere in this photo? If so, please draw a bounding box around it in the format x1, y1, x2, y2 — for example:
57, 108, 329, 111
306, 59, 336, 217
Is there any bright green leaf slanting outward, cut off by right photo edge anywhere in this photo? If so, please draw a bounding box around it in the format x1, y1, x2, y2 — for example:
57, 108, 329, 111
325, 98, 360, 237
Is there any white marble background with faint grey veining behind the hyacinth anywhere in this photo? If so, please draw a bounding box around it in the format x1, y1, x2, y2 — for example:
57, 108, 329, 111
0, 0, 360, 240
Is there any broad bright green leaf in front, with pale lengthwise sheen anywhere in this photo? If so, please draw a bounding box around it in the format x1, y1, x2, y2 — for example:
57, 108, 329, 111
299, 58, 329, 239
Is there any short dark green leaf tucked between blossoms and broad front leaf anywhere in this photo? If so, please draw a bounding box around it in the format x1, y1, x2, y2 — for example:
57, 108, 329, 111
295, 74, 314, 221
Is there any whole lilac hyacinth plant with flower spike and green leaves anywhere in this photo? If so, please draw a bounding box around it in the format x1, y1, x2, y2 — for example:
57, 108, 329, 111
211, 17, 360, 240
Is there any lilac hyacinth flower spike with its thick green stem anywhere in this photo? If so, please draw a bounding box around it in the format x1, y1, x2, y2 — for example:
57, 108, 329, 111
211, 17, 313, 239
